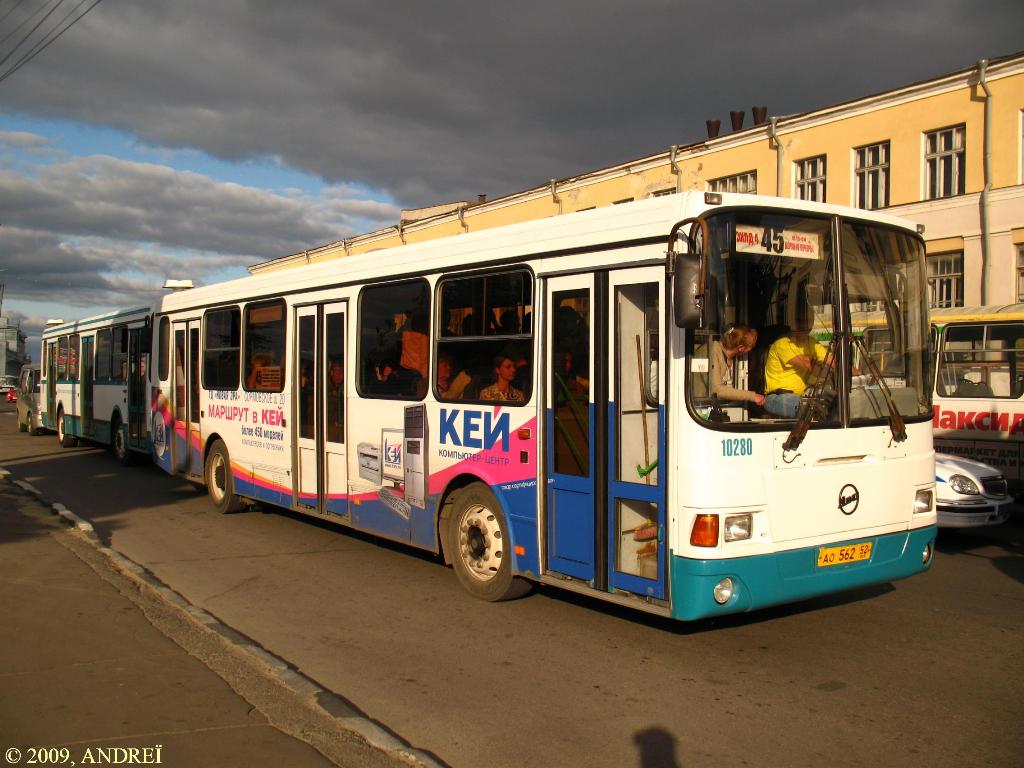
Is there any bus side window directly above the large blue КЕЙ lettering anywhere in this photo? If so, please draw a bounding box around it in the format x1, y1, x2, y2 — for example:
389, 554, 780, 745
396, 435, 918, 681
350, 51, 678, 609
433, 269, 534, 406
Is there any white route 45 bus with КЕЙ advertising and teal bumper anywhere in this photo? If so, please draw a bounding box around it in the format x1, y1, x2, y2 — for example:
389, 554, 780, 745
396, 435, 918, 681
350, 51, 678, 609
121, 193, 936, 620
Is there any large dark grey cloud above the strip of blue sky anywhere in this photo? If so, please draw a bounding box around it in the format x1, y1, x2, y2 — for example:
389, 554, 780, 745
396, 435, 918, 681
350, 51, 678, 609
0, 0, 1024, 205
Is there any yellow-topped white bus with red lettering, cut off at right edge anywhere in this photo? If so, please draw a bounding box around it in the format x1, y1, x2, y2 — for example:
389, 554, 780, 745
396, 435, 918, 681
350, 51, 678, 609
931, 304, 1024, 493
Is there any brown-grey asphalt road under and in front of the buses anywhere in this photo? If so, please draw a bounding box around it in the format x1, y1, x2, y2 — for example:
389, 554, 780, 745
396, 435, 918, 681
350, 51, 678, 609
0, 406, 1024, 768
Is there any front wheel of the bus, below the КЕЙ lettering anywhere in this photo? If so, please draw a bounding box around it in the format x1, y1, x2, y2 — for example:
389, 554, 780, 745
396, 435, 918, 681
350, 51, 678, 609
445, 482, 529, 602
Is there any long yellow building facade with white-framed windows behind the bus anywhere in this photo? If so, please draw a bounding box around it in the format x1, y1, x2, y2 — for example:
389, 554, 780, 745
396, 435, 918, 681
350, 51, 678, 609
250, 53, 1024, 306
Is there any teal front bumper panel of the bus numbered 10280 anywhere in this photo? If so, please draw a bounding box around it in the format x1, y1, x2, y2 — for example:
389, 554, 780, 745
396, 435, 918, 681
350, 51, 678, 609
669, 525, 935, 621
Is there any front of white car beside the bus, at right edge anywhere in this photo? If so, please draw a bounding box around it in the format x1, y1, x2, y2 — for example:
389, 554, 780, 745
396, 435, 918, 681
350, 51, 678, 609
935, 453, 1013, 528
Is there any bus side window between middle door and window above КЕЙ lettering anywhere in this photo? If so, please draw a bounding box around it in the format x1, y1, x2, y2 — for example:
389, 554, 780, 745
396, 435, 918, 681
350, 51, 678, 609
357, 280, 430, 400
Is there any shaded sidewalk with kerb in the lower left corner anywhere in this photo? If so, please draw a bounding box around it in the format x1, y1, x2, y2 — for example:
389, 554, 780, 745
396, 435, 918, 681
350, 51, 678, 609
0, 477, 423, 768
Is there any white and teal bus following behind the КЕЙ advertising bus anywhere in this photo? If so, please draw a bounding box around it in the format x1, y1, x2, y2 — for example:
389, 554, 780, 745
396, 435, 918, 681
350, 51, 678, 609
40, 307, 152, 464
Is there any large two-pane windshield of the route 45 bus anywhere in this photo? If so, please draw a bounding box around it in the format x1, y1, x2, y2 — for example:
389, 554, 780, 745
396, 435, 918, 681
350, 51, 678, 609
689, 210, 930, 429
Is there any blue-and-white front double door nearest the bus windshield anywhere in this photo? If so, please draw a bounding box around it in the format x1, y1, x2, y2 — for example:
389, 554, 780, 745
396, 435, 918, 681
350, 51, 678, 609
545, 267, 667, 599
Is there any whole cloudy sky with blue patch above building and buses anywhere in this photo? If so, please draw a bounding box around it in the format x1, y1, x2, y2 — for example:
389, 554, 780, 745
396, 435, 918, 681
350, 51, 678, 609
0, 0, 1024, 358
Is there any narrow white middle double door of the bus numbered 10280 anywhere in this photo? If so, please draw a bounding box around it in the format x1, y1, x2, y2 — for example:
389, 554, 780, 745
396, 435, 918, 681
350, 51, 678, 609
292, 303, 349, 518
